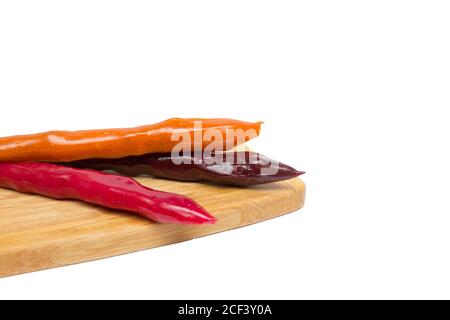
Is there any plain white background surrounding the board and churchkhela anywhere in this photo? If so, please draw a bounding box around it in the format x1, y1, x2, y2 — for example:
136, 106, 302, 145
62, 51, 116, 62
0, 0, 450, 299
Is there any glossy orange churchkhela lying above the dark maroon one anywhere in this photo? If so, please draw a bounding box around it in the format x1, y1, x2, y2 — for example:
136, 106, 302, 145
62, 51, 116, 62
0, 118, 261, 162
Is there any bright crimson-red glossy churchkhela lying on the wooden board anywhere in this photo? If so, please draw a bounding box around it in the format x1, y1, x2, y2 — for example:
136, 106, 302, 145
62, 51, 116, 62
0, 162, 216, 224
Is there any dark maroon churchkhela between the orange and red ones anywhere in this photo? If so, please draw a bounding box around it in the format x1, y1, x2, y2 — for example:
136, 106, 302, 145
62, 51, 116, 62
65, 151, 304, 186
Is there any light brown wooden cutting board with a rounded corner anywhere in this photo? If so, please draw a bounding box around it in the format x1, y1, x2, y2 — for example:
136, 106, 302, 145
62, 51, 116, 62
0, 178, 305, 277
